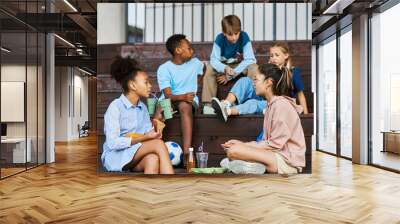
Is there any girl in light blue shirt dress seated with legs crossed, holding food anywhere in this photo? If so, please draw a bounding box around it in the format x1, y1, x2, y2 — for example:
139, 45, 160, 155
101, 57, 174, 174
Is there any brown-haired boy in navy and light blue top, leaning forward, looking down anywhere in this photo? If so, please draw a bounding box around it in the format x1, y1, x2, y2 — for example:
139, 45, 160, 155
202, 15, 257, 113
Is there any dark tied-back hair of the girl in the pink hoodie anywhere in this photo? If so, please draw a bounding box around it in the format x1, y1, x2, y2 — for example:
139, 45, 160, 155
258, 64, 292, 96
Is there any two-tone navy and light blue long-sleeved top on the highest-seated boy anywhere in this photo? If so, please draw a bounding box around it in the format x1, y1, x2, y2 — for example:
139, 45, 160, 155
210, 31, 256, 74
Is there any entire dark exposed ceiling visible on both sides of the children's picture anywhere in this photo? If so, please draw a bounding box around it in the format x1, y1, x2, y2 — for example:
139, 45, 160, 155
0, 0, 396, 71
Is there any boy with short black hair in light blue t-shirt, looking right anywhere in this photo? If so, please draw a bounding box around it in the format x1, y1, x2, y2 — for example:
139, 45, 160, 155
157, 34, 204, 153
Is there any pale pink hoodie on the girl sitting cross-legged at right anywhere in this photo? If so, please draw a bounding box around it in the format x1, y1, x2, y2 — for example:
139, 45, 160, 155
259, 96, 306, 167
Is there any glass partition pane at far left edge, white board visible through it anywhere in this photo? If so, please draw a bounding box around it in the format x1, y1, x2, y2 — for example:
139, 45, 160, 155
0, 32, 27, 178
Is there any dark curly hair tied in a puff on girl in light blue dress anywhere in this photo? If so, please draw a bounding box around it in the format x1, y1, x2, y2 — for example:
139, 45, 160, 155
110, 56, 143, 93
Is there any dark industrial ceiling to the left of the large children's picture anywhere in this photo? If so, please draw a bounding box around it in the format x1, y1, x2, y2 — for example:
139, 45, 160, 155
0, 0, 97, 73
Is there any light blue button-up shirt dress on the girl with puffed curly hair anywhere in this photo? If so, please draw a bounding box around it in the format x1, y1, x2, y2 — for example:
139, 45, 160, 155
101, 94, 152, 171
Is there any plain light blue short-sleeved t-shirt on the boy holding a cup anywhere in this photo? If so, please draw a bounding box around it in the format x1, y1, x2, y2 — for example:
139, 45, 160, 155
157, 58, 204, 105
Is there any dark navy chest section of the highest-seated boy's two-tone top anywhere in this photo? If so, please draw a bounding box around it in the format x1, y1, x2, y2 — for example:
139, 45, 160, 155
215, 31, 250, 59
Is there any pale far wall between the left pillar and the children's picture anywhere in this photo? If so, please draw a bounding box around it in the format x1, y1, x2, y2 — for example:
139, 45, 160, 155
55, 67, 89, 141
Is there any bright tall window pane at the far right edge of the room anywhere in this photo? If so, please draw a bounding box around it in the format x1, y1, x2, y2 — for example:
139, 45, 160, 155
371, 4, 400, 170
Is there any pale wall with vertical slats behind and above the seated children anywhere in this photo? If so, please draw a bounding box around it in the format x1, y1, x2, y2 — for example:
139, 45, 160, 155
97, 3, 311, 44
